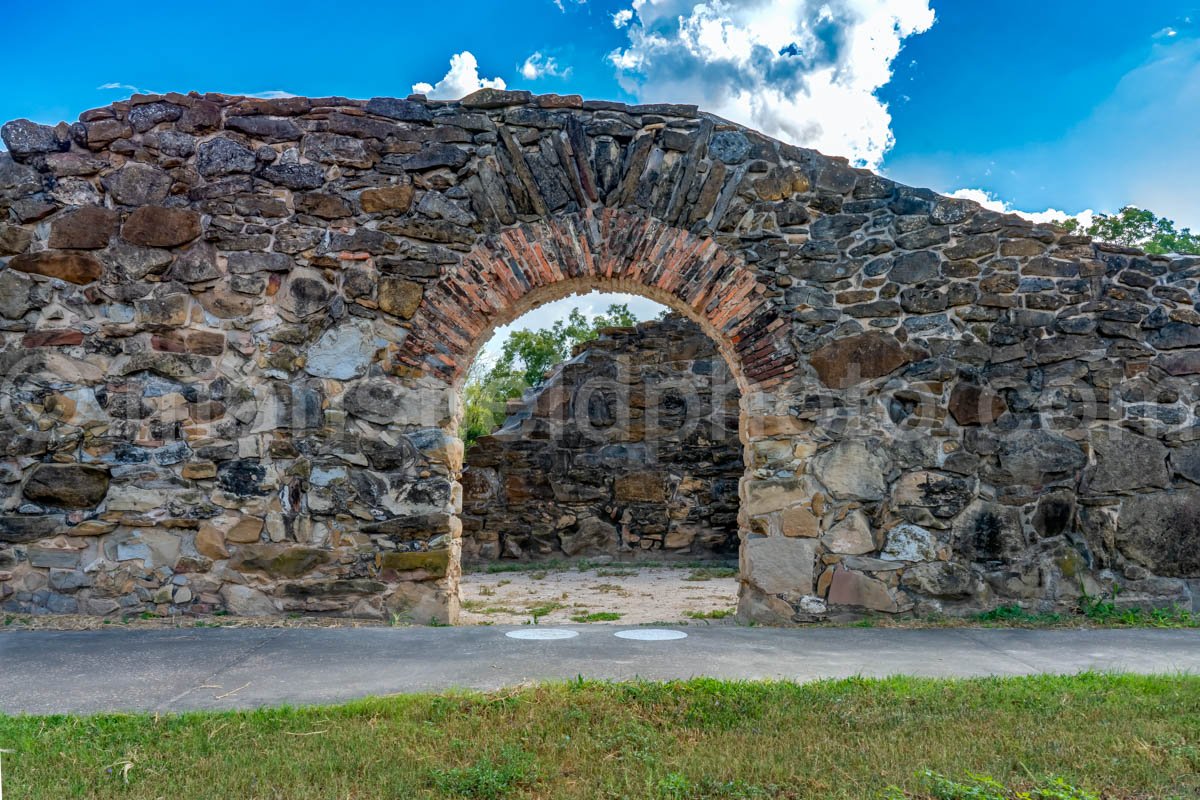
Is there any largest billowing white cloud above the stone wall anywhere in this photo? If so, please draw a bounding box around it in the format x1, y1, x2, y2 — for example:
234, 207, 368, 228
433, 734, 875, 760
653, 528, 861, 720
610, 0, 934, 168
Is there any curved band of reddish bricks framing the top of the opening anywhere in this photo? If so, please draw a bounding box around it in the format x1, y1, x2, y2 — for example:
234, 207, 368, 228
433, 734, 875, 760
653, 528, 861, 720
401, 209, 796, 391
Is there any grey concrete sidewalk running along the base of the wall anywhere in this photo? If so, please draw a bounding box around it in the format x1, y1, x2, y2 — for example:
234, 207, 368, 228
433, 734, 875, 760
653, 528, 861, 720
0, 625, 1200, 714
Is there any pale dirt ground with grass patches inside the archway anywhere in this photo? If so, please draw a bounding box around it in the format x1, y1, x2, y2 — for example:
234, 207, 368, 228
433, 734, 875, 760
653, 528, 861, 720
460, 565, 738, 625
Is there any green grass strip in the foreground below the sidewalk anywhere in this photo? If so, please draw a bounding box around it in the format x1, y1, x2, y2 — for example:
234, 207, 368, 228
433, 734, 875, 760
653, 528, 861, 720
0, 674, 1200, 800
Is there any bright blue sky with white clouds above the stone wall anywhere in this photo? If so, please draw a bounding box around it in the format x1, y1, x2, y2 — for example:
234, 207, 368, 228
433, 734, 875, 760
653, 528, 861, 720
0, 0, 1200, 350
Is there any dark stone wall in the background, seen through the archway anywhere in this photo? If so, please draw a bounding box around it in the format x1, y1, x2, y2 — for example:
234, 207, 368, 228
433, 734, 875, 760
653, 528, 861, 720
462, 315, 744, 560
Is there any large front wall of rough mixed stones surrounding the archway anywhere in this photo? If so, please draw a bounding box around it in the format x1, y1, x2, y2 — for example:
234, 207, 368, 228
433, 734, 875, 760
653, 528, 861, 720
0, 90, 1200, 622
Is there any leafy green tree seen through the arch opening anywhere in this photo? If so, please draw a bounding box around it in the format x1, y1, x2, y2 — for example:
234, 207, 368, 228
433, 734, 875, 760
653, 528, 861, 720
458, 303, 637, 447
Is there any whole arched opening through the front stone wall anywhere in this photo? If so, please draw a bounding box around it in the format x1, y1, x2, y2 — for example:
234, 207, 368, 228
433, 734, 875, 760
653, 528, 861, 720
460, 291, 745, 624
